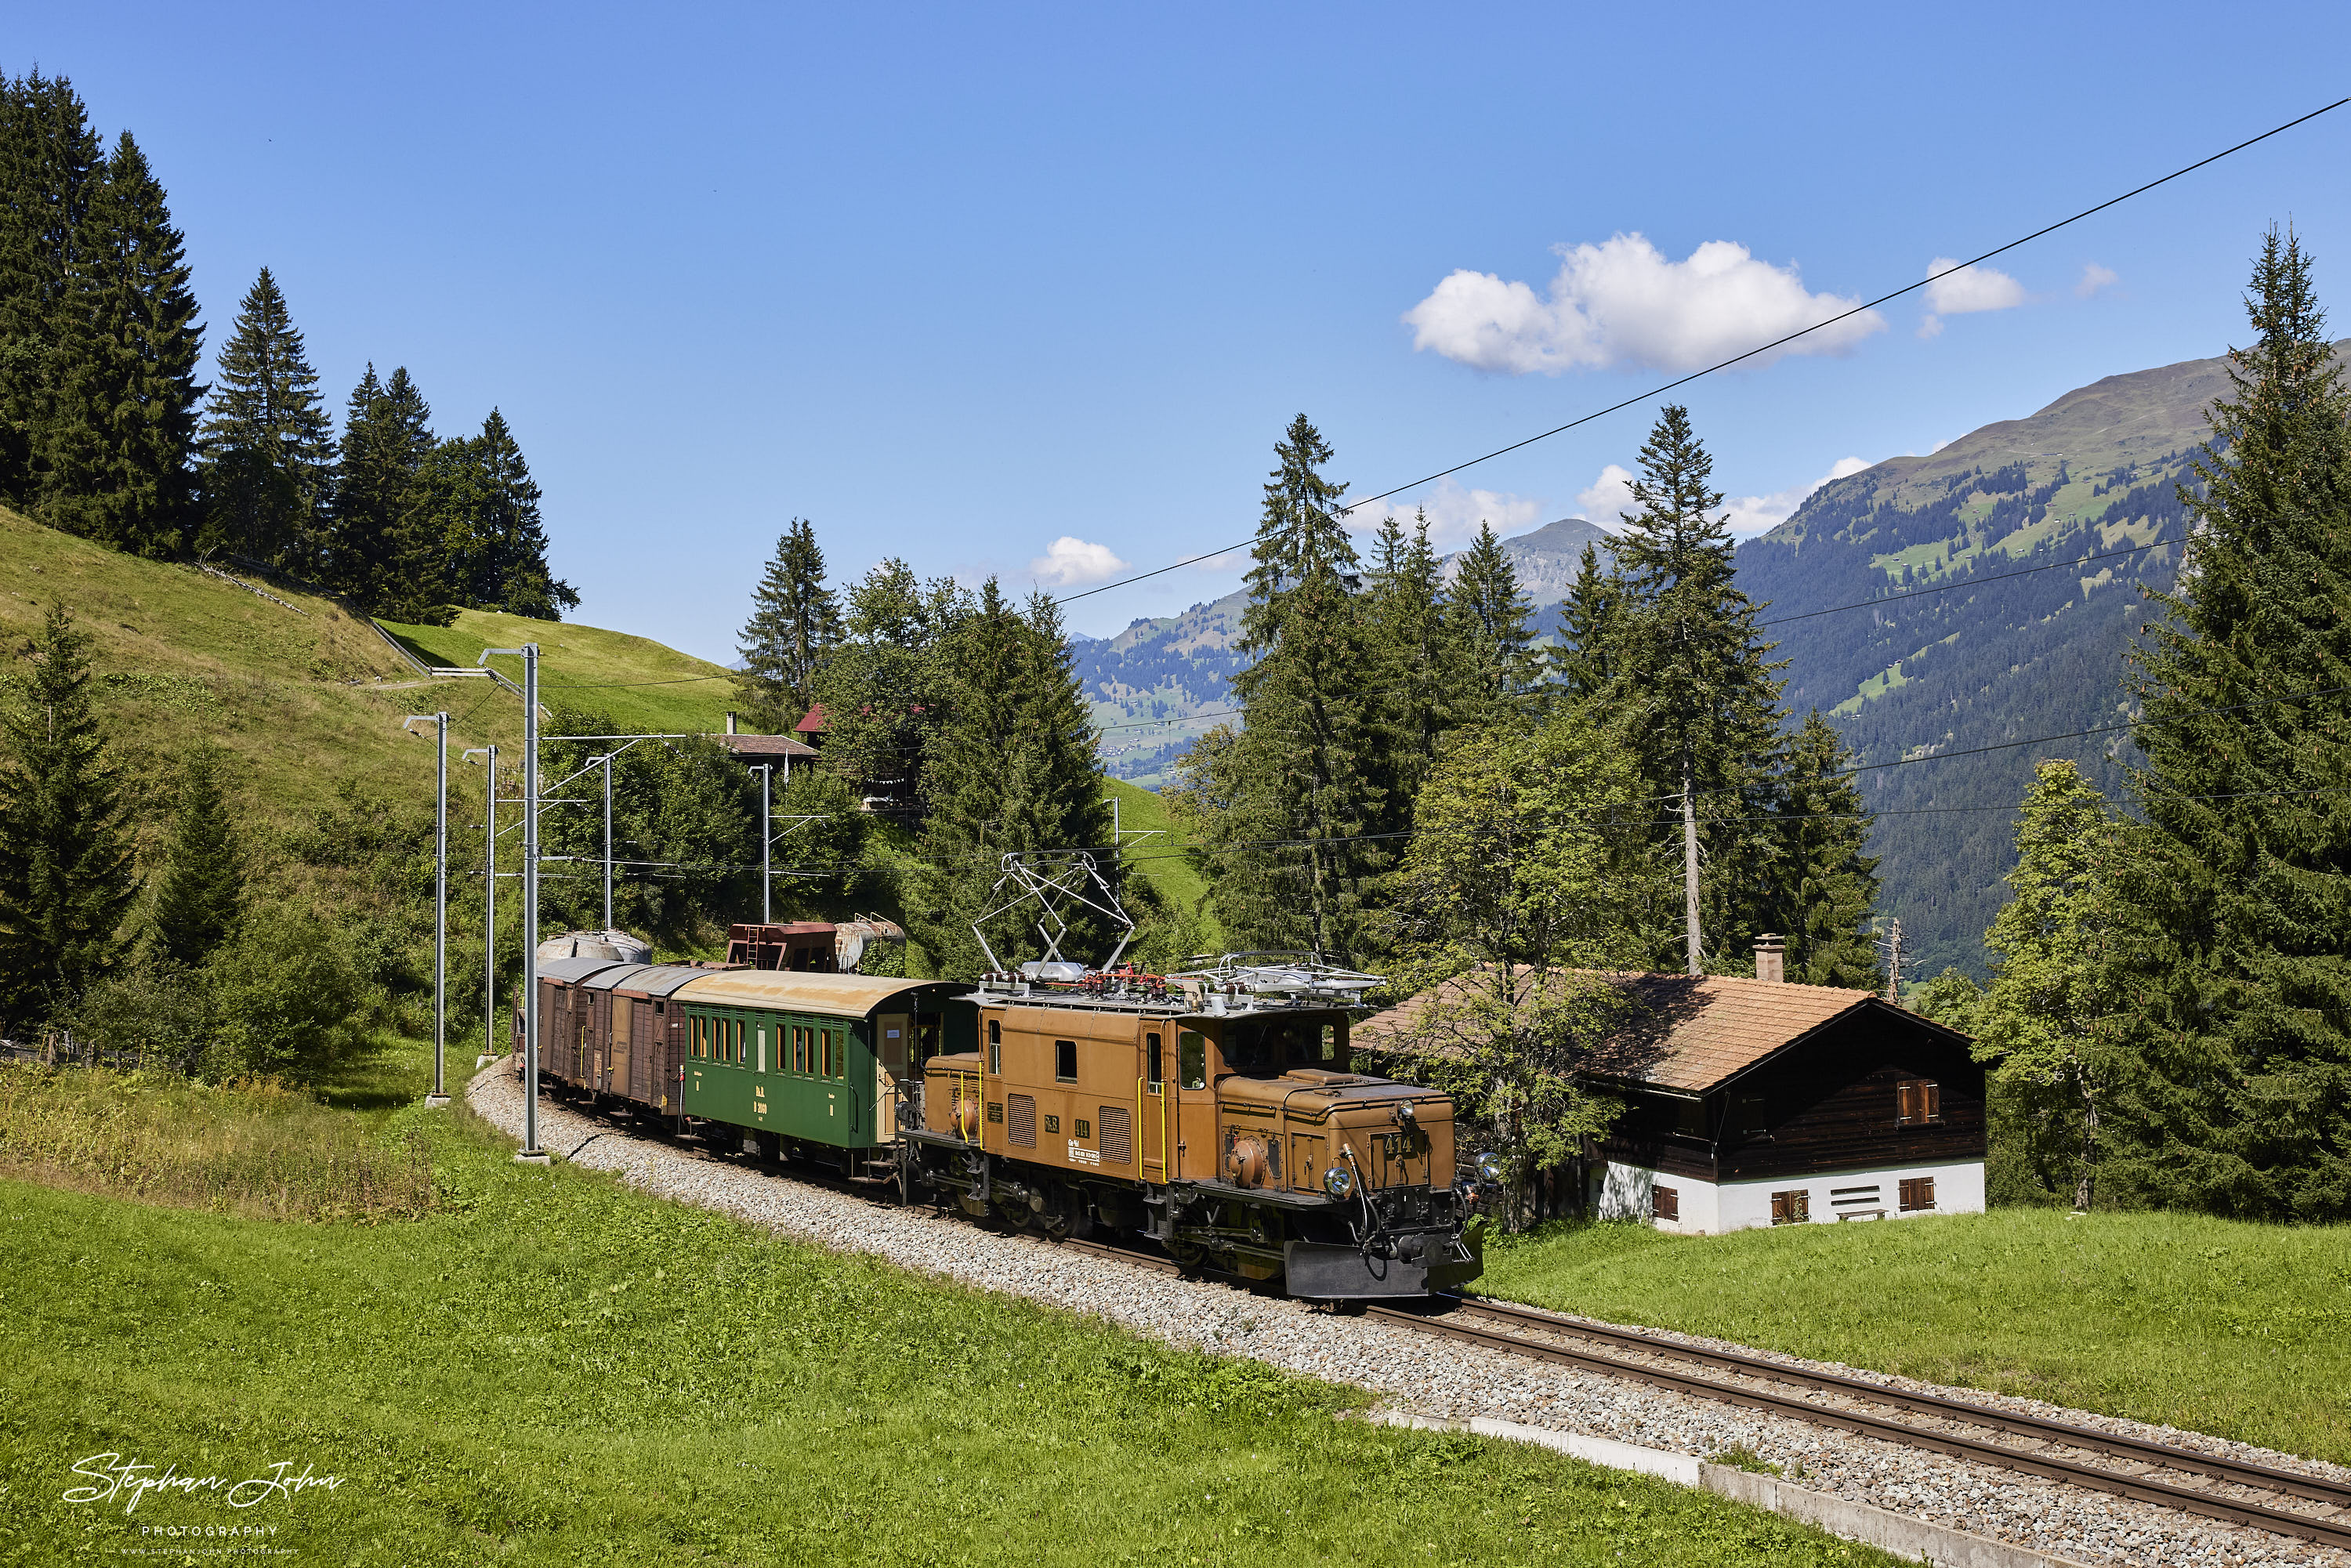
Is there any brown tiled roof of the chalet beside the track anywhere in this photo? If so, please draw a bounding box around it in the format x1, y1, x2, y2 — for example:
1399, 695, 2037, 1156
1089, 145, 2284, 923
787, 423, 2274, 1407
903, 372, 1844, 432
1354, 971, 1933, 1093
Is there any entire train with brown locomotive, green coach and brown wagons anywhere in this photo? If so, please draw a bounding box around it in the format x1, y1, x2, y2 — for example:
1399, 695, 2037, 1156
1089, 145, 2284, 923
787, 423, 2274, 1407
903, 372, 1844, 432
524, 867, 1483, 1300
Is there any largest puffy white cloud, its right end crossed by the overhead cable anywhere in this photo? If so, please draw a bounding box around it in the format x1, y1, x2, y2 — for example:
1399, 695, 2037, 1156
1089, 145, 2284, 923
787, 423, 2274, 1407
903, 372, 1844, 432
1404, 235, 1886, 376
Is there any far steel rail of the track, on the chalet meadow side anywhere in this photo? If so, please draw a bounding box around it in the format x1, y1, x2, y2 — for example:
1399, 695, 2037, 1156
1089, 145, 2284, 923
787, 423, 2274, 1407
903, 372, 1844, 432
1458, 1295, 2351, 1509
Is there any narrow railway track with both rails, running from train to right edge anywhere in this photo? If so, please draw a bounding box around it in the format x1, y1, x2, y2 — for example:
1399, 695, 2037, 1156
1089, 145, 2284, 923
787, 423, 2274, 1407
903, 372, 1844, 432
534, 1107, 2351, 1549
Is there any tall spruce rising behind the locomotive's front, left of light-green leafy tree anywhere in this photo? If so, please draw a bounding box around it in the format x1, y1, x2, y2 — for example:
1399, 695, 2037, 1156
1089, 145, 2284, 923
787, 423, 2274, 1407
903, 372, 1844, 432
1180, 414, 1392, 961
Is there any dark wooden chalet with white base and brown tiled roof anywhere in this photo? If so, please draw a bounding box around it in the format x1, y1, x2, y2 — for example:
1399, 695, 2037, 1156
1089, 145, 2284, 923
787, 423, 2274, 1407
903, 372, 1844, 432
1354, 945, 1984, 1234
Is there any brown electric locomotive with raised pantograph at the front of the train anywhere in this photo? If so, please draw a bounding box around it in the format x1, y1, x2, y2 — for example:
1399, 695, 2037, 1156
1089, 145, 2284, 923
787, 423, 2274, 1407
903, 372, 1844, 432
900, 954, 1481, 1300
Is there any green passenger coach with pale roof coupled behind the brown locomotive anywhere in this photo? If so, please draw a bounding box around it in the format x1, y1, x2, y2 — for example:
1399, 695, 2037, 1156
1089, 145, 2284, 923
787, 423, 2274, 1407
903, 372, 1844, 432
672, 971, 978, 1175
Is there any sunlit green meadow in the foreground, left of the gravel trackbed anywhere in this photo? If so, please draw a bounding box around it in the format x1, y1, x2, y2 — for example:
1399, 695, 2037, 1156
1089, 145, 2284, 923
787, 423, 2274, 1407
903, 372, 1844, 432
0, 1072, 1890, 1566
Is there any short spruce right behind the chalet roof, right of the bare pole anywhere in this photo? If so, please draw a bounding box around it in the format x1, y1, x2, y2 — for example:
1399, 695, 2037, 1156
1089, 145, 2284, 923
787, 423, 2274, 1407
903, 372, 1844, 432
1773, 708, 1883, 990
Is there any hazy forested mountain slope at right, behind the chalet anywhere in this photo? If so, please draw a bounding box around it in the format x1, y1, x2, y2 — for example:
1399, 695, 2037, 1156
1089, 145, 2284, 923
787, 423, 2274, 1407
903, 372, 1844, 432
1740, 360, 2342, 976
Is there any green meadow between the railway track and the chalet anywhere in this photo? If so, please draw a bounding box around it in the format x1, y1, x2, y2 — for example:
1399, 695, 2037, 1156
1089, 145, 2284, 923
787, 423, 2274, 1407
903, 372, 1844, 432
1479, 1208, 2351, 1465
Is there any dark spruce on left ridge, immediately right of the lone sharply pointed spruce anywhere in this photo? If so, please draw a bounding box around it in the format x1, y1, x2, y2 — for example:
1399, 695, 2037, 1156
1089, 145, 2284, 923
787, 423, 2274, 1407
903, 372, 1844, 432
324, 364, 449, 623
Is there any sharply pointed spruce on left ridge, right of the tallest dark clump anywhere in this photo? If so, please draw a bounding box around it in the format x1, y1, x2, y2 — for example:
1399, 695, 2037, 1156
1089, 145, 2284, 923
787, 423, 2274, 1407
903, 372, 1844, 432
197, 268, 334, 574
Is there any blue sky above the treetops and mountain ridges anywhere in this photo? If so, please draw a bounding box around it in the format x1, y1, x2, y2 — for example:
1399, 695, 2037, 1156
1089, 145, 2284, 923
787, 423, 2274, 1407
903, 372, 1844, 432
18, 5, 2351, 658
